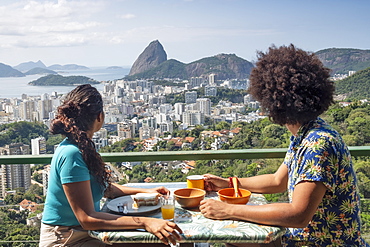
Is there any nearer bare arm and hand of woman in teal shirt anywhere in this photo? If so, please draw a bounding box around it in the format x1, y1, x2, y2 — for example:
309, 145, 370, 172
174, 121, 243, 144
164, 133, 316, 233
63, 181, 182, 244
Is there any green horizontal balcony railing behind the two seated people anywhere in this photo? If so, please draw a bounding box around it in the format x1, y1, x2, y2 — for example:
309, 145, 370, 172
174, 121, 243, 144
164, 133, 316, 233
0, 146, 370, 164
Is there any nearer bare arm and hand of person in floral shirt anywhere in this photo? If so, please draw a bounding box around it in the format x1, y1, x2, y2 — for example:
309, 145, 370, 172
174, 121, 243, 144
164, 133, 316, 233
200, 181, 326, 228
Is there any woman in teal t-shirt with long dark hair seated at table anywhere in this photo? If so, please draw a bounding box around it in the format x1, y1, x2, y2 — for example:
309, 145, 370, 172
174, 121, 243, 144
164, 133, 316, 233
40, 84, 182, 246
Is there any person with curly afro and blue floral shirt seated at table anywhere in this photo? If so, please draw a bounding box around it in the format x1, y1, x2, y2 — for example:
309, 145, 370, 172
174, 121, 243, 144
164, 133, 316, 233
200, 45, 367, 246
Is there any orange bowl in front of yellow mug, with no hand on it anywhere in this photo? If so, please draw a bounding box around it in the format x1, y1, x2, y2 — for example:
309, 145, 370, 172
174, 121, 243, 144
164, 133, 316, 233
173, 188, 206, 208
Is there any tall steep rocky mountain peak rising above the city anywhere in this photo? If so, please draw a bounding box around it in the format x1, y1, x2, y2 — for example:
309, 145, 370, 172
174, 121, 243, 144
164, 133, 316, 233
129, 40, 167, 75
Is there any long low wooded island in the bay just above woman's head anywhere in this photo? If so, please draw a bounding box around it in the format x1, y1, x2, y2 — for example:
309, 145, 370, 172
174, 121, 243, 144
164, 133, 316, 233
28, 75, 100, 86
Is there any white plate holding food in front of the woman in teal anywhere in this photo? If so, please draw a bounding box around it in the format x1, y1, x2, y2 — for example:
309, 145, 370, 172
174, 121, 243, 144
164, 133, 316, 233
107, 196, 161, 215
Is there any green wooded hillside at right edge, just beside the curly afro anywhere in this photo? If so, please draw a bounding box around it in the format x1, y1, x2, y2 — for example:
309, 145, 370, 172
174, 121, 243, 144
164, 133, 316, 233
335, 67, 370, 100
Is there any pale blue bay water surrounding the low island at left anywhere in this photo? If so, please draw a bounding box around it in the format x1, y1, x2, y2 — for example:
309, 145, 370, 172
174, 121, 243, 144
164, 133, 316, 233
0, 67, 130, 98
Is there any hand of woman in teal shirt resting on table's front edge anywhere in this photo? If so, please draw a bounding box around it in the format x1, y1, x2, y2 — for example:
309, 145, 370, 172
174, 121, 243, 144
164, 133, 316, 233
144, 218, 182, 245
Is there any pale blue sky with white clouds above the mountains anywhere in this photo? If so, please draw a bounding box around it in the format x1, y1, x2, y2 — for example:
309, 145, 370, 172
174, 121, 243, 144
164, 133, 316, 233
0, 0, 370, 67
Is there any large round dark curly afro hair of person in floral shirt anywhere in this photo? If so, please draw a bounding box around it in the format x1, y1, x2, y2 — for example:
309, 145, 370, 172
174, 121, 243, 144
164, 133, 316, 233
248, 44, 335, 125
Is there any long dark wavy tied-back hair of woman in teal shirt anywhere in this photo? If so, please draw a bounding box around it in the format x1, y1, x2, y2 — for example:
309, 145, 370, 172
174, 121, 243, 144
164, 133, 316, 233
50, 84, 109, 187
